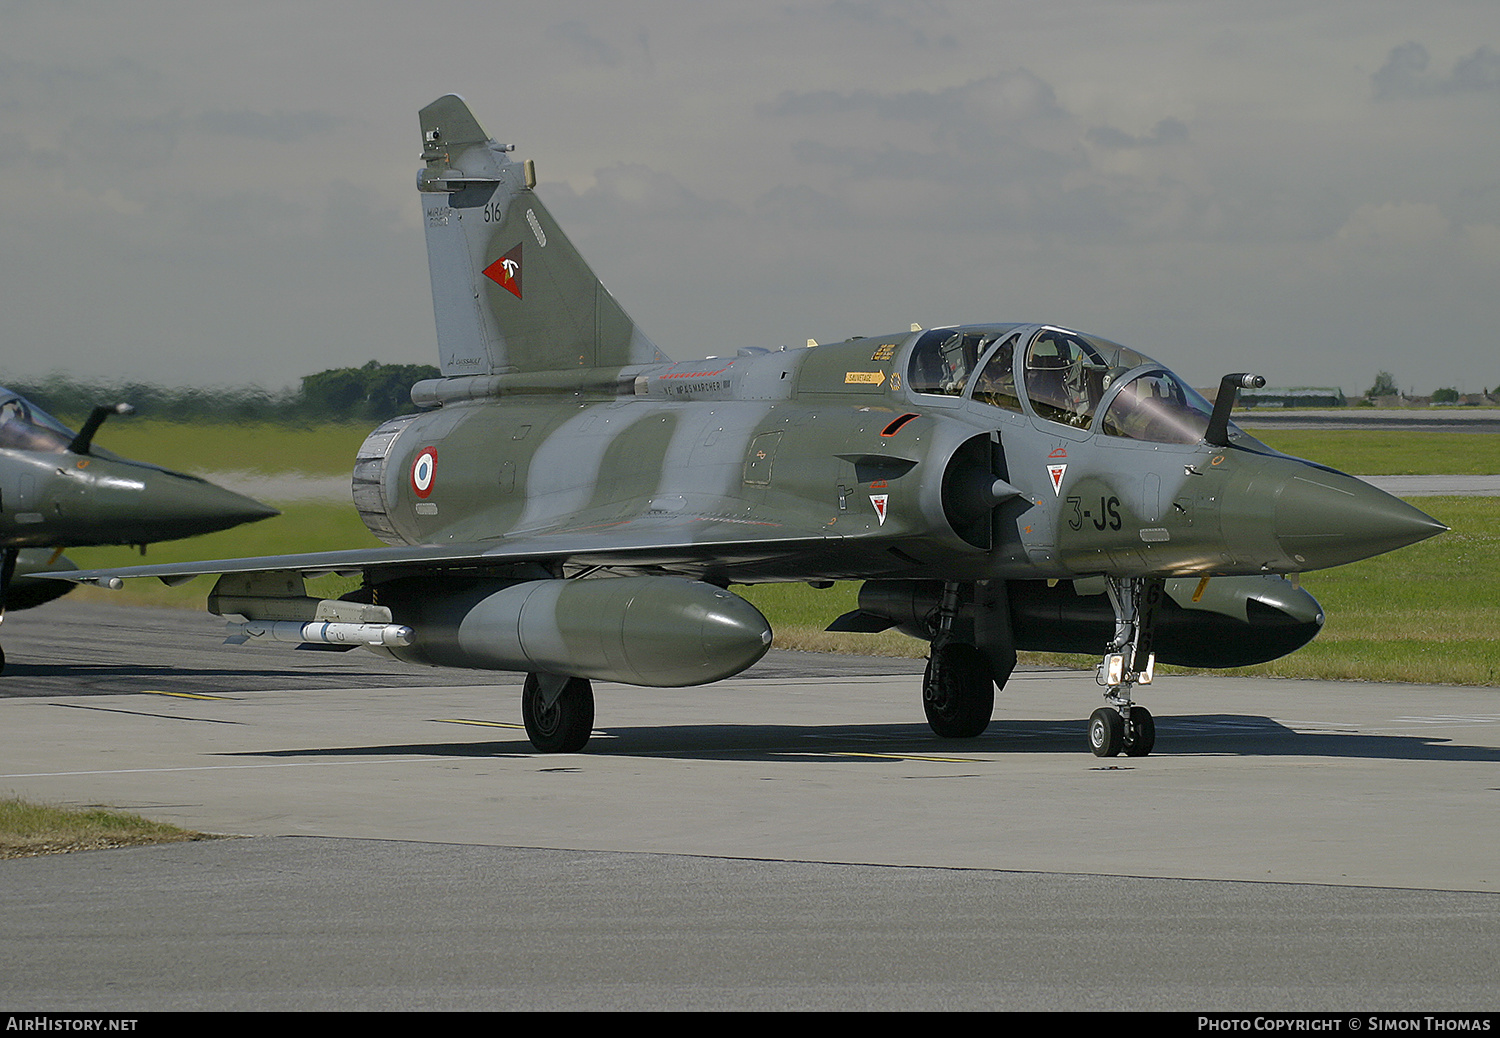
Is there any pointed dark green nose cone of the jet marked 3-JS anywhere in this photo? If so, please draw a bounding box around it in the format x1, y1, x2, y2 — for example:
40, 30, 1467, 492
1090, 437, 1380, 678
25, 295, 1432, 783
1274, 465, 1448, 570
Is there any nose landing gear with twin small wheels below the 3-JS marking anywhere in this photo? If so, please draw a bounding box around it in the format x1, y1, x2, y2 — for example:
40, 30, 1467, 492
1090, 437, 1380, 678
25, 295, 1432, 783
1089, 576, 1164, 758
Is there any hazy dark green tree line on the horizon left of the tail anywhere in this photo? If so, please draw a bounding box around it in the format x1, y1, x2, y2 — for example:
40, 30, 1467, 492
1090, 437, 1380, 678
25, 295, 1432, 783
8, 360, 440, 425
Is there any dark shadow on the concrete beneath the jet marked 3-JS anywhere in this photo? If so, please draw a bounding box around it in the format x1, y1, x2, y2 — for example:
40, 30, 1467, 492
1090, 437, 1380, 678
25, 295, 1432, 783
224, 714, 1500, 767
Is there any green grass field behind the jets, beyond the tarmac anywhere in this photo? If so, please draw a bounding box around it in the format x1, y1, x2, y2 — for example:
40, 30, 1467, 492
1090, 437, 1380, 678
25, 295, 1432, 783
49, 422, 1500, 686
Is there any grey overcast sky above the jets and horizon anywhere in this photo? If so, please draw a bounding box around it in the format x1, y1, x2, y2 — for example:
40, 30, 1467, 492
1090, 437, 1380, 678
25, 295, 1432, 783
0, 0, 1500, 395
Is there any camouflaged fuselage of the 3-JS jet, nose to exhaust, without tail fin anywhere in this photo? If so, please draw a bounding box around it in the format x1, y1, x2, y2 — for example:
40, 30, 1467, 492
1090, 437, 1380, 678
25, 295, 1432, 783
356, 324, 1442, 582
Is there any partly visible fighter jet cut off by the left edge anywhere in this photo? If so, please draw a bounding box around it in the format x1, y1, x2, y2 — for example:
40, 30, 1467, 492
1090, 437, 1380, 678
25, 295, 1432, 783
0, 387, 279, 671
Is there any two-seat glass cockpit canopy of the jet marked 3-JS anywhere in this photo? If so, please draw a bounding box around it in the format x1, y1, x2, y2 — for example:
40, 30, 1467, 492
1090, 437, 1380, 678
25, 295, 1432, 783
908, 326, 1214, 444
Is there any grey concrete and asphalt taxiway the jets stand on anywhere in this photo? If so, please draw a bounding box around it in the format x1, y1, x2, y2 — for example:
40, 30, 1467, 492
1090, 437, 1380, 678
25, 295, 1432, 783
0, 600, 1500, 1011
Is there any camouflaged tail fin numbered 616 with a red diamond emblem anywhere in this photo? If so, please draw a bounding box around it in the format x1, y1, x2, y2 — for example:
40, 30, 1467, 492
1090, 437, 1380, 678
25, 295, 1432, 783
417, 95, 665, 375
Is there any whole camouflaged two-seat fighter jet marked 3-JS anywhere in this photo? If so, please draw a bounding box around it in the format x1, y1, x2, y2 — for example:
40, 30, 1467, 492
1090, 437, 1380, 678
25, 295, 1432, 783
55, 96, 1445, 756
